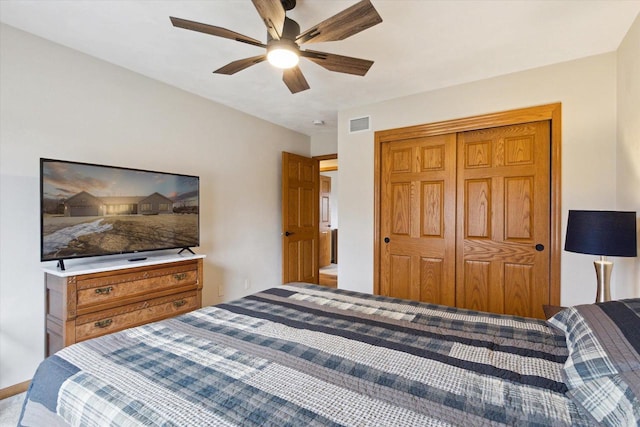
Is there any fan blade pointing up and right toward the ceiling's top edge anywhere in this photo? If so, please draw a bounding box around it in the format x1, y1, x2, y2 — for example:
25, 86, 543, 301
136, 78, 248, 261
296, 0, 382, 45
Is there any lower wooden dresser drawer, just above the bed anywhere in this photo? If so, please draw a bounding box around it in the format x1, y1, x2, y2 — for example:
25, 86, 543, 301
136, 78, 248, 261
75, 291, 199, 342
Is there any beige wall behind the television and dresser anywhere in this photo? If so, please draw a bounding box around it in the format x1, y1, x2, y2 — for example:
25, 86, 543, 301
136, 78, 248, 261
0, 25, 310, 389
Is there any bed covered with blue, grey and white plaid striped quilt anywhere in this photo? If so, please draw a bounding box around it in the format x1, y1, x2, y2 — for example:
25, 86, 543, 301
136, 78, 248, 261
19, 283, 640, 427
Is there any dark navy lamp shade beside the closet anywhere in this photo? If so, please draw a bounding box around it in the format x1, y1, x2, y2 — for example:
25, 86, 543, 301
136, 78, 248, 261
564, 210, 638, 257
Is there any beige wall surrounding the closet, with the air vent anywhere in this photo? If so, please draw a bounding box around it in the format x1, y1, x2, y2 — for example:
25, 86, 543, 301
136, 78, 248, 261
338, 52, 628, 305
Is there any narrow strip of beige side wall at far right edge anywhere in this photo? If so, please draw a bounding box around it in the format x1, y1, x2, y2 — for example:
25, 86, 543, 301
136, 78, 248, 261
615, 12, 640, 295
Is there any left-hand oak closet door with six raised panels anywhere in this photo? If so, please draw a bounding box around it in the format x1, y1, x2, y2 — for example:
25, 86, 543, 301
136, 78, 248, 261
380, 134, 456, 305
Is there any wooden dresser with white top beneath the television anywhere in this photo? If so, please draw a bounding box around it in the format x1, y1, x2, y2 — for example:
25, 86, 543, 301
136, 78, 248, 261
45, 255, 204, 356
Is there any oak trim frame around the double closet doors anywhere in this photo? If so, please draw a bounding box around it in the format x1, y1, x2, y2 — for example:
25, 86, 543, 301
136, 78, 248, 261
373, 103, 562, 305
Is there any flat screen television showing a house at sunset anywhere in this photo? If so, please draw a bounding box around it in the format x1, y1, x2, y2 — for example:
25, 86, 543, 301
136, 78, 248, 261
40, 159, 200, 269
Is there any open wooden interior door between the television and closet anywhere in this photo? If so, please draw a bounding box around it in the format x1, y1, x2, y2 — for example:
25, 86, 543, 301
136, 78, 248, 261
282, 152, 319, 283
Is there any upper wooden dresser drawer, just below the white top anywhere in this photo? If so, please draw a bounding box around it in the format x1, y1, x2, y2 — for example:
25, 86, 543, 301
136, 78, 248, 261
77, 263, 198, 314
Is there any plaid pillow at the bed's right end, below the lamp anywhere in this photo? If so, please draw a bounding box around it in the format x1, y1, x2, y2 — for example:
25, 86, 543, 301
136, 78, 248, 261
549, 298, 640, 426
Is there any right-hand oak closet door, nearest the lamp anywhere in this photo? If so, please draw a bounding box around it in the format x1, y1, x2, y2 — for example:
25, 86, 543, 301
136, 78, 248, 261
457, 121, 550, 318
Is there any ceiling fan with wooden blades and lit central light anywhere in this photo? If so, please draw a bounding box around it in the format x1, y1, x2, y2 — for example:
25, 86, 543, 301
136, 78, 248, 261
170, 0, 382, 93
